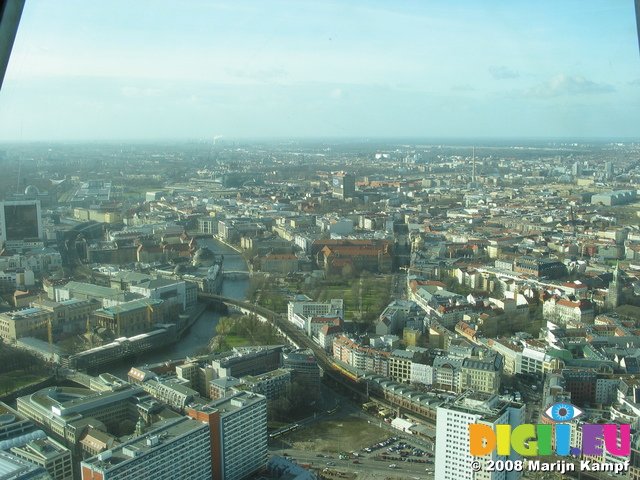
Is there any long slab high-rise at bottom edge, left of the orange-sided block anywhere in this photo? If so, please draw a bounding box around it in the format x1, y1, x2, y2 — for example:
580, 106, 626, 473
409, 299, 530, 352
81, 417, 211, 480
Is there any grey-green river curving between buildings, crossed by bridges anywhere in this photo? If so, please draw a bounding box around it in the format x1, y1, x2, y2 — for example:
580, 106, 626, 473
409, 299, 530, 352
106, 238, 249, 378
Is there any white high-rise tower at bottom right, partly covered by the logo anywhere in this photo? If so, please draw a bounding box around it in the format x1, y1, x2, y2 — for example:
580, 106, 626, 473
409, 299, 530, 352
435, 391, 525, 480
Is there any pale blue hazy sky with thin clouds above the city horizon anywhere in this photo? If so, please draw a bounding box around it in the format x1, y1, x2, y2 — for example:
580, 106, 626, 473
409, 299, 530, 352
0, 0, 640, 142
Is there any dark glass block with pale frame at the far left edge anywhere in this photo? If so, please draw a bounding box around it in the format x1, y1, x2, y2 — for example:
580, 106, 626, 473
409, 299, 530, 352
0, 200, 43, 243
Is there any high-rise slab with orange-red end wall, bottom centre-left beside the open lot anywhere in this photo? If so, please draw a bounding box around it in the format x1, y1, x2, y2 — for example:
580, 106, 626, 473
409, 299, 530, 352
190, 392, 267, 480
